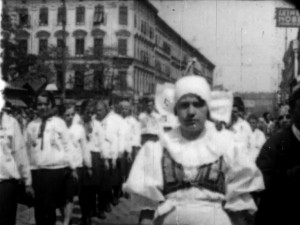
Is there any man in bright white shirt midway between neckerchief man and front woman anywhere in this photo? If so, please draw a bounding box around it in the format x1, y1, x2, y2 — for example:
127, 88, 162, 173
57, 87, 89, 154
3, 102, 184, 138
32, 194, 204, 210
96, 101, 127, 217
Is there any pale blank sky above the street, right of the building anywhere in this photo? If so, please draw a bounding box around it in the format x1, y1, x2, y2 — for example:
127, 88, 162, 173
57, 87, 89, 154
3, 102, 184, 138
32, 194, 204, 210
151, 0, 298, 92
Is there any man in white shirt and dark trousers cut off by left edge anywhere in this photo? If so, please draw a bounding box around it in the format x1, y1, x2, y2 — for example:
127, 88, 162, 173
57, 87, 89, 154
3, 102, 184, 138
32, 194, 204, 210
0, 107, 33, 225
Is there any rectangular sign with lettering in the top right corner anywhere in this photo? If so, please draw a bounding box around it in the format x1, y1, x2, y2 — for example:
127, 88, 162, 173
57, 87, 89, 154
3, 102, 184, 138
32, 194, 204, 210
276, 8, 300, 27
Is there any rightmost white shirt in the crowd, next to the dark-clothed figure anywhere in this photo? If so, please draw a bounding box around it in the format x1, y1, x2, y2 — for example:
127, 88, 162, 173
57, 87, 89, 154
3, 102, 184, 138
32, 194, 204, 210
248, 129, 266, 162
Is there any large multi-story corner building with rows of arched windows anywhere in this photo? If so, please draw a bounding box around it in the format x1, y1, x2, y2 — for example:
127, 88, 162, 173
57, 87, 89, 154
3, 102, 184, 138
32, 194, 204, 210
6, 0, 215, 99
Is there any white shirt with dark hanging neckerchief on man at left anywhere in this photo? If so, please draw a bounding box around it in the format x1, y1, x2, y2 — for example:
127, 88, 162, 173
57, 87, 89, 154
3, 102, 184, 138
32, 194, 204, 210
27, 116, 75, 169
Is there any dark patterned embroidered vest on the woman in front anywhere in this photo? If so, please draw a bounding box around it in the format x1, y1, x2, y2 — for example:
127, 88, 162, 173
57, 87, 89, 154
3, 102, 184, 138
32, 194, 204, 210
162, 149, 225, 195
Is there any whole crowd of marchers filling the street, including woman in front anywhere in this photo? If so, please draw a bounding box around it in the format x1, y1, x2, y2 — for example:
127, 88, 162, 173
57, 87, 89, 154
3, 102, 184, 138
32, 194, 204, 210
0, 75, 300, 225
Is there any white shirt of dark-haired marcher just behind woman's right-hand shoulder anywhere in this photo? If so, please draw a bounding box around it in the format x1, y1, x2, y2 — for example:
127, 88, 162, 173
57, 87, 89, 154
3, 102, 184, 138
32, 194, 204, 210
231, 118, 252, 154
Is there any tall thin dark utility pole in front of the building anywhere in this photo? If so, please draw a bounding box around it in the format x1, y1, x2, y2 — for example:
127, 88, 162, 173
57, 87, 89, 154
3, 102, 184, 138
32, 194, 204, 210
61, 0, 67, 102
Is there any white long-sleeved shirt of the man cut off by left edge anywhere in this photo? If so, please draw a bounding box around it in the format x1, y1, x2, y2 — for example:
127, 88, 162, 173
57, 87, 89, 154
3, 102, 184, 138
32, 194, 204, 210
0, 112, 31, 185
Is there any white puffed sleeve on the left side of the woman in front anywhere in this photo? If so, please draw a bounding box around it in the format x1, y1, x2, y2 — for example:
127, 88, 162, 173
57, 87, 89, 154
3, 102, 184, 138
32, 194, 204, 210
123, 142, 165, 202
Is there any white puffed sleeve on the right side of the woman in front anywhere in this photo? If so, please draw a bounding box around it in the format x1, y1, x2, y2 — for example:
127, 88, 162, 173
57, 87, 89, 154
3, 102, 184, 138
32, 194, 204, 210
224, 134, 264, 213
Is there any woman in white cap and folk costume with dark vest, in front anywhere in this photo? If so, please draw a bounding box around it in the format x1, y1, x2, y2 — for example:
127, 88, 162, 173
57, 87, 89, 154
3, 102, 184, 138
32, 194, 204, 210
123, 75, 264, 225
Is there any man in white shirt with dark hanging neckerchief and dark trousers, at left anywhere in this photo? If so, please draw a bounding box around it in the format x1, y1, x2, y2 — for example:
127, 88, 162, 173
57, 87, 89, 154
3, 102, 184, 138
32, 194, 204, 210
26, 92, 77, 225
